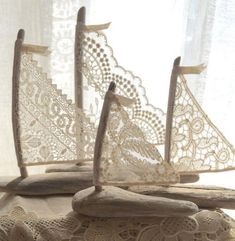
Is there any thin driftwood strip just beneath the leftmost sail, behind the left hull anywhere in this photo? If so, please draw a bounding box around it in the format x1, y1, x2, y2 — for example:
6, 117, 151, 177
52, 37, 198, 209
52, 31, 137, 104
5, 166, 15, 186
46, 161, 93, 173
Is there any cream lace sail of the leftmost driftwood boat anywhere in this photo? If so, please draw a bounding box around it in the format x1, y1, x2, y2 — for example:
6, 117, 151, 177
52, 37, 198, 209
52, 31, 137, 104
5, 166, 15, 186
15, 53, 95, 165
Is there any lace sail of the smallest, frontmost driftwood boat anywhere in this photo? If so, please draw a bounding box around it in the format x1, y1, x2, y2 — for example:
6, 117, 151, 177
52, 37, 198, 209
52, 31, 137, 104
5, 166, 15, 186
98, 102, 178, 185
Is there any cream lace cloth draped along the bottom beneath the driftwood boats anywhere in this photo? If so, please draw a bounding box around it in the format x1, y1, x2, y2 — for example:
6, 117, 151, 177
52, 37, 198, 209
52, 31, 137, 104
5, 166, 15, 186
0, 207, 235, 241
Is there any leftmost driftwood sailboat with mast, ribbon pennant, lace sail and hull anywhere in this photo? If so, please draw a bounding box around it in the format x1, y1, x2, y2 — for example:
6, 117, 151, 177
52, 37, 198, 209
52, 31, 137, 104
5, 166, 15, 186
0, 30, 95, 194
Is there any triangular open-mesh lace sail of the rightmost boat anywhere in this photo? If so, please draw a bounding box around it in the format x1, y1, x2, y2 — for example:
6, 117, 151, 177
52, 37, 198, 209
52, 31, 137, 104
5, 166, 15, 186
171, 74, 235, 173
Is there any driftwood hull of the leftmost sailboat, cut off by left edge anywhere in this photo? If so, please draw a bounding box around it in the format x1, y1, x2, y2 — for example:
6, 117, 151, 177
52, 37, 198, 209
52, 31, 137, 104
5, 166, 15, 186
0, 172, 92, 195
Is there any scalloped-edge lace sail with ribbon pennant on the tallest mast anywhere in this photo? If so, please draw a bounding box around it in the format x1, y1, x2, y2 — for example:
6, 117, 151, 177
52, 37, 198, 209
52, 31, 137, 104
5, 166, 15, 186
76, 24, 165, 144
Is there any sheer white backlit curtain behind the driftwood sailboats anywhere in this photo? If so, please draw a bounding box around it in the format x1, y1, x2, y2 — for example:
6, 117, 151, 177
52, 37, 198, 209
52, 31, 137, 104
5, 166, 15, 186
0, 0, 235, 192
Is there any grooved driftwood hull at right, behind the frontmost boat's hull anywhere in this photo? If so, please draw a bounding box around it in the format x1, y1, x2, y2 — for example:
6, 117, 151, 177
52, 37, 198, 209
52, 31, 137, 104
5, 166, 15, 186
129, 184, 235, 209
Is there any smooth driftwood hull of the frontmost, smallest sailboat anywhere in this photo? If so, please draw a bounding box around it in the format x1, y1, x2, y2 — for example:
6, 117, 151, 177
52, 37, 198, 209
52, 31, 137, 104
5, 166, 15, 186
72, 186, 198, 217
